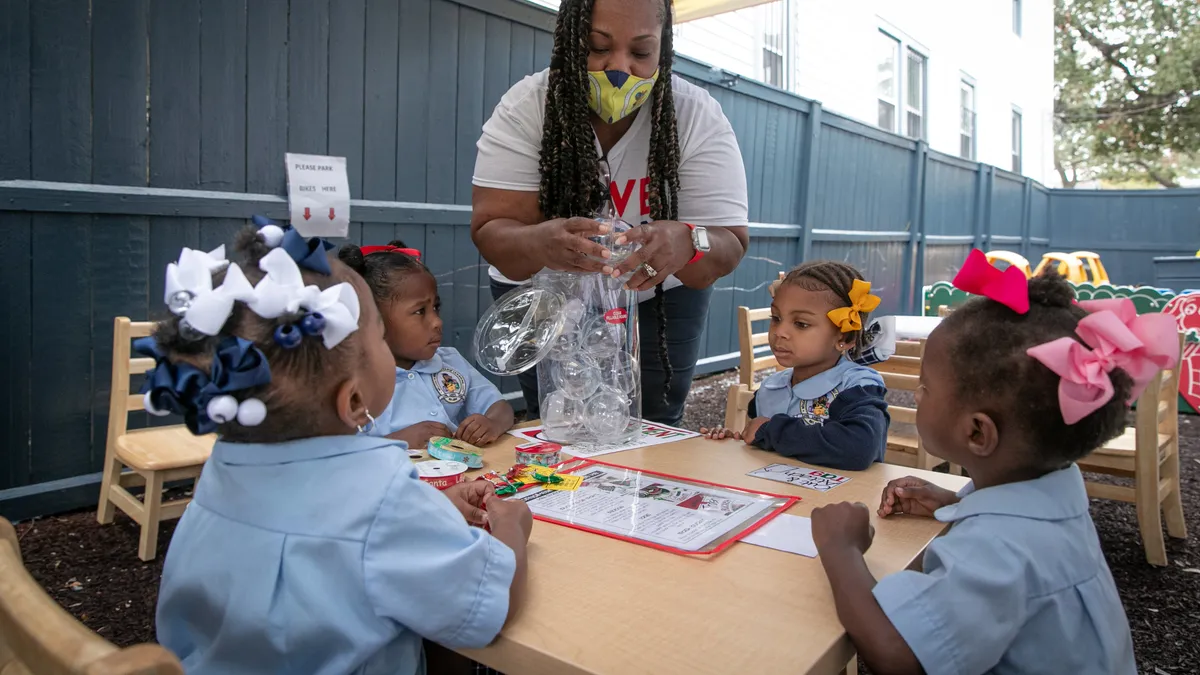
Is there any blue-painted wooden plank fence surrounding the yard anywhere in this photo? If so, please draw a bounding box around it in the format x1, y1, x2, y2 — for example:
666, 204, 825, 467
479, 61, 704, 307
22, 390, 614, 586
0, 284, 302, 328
0, 0, 1200, 518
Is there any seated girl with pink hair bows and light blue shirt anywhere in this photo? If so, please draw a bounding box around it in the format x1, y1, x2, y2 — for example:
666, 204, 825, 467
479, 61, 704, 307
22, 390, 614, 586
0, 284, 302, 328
812, 251, 1178, 675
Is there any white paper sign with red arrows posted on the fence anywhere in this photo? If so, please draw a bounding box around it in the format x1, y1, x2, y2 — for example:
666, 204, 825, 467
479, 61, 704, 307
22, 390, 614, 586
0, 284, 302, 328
284, 153, 350, 237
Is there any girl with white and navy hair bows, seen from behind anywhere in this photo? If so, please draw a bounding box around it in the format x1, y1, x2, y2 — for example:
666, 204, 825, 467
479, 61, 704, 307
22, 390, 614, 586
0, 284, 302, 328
148, 226, 532, 675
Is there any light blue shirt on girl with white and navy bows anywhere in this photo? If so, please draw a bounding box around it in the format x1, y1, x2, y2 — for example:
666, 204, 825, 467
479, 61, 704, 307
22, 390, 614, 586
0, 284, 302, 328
157, 436, 516, 675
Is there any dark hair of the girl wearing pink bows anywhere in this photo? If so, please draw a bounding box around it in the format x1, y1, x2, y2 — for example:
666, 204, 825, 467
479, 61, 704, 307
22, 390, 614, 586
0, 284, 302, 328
938, 269, 1133, 461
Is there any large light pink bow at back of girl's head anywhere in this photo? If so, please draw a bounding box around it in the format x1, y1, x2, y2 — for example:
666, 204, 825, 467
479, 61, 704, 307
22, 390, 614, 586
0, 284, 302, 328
1026, 298, 1180, 424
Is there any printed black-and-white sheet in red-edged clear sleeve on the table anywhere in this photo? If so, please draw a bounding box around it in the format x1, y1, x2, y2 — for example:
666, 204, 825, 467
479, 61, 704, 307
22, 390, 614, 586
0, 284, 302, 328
510, 465, 775, 551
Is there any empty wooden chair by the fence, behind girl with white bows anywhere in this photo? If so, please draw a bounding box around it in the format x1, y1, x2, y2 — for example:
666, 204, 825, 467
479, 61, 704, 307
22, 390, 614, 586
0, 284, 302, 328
96, 316, 216, 561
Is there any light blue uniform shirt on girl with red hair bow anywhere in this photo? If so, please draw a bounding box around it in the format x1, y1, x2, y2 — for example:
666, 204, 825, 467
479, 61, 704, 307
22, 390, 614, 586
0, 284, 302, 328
370, 347, 500, 436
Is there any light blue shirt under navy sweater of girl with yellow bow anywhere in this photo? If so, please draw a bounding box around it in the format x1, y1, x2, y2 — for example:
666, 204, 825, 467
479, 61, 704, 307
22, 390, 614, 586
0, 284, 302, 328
755, 357, 883, 424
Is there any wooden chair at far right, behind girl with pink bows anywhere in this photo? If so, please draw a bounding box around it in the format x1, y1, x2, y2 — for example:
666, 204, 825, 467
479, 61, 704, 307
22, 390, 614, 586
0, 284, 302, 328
1078, 334, 1188, 566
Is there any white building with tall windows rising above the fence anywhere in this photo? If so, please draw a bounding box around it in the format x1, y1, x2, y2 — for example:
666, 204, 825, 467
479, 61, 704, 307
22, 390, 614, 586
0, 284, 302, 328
676, 0, 1057, 186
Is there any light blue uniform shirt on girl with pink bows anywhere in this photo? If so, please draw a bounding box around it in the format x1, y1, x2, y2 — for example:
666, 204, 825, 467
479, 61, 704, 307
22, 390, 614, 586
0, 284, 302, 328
875, 465, 1138, 675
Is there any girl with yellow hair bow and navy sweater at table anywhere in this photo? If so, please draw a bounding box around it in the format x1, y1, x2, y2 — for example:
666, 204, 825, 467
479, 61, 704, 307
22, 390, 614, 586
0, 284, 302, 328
701, 261, 889, 471
